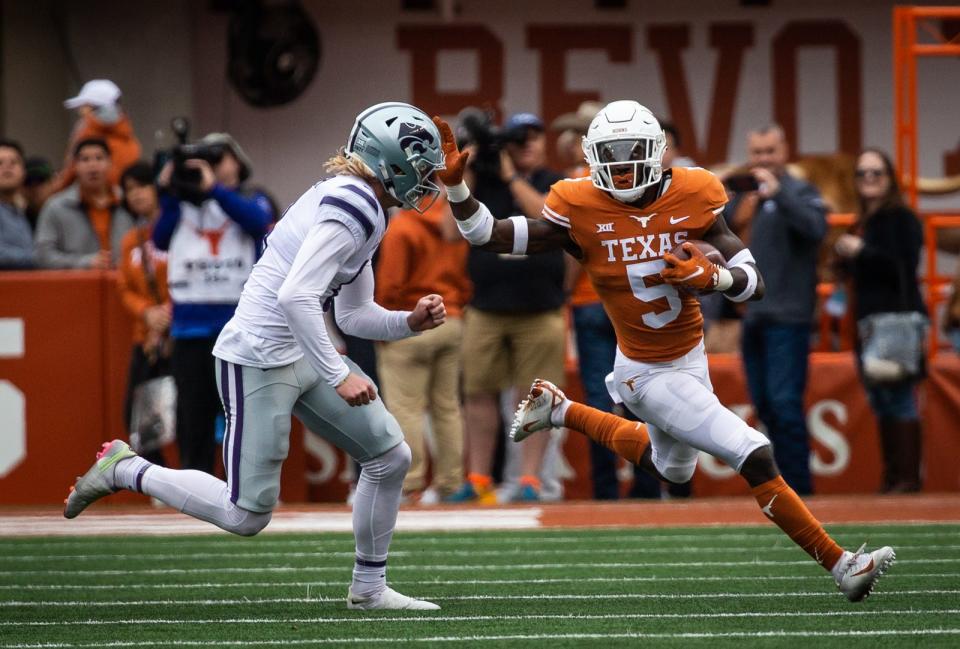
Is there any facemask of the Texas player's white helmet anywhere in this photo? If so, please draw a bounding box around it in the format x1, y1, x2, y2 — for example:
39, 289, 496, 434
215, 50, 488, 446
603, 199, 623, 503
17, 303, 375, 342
583, 132, 666, 203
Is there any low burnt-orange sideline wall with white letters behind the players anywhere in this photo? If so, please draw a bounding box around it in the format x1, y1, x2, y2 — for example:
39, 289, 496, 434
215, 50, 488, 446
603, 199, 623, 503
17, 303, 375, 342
0, 271, 960, 505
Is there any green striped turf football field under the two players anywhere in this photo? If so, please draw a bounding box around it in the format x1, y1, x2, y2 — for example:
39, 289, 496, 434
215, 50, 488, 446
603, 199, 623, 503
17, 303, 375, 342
0, 524, 960, 648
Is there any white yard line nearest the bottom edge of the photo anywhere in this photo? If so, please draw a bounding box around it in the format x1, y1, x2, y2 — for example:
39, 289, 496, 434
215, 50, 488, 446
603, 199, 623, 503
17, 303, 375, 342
0, 628, 960, 649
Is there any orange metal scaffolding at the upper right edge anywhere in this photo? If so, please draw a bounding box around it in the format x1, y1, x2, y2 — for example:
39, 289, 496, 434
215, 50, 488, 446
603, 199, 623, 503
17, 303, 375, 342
893, 6, 960, 356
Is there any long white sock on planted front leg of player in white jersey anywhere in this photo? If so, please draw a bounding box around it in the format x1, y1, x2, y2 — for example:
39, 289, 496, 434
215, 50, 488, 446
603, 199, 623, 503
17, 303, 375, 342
350, 442, 410, 597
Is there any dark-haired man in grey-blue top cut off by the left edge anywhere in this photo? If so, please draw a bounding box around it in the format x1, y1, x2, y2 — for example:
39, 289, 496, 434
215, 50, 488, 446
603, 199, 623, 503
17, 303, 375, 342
0, 139, 34, 270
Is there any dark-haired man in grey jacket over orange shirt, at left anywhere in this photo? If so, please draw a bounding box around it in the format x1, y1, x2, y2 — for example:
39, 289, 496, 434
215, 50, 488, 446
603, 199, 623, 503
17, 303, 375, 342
36, 138, 133, 269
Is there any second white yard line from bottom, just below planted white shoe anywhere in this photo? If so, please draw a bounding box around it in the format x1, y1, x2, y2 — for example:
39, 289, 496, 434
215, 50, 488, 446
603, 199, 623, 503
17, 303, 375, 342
0, 608, 960, 627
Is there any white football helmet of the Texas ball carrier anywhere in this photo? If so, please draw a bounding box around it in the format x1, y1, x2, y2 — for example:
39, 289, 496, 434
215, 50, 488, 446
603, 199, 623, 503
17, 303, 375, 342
583, 101, 667, 203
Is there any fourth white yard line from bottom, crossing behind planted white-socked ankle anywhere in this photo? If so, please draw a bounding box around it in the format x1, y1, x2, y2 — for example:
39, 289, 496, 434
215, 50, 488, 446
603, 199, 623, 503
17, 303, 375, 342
0, 570, 960, 601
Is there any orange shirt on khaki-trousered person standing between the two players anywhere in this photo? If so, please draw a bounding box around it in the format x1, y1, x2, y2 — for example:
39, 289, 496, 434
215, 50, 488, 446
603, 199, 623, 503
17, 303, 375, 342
376, 198, 473, 317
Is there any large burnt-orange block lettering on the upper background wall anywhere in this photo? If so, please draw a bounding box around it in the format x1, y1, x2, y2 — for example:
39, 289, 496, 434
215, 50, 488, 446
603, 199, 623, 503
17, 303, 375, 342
396, 20, 863, 165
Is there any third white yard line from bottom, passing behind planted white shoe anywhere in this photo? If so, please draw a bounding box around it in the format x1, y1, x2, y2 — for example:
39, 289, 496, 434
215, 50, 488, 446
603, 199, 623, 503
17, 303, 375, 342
0, 589, 960, 609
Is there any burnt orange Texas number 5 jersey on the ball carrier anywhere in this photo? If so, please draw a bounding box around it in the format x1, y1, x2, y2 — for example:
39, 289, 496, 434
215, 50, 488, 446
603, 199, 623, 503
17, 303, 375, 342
543, 167, 727, 363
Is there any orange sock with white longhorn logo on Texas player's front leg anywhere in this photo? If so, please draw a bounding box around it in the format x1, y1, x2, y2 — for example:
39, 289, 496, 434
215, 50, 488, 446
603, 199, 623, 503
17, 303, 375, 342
751, 476, 843, 570
